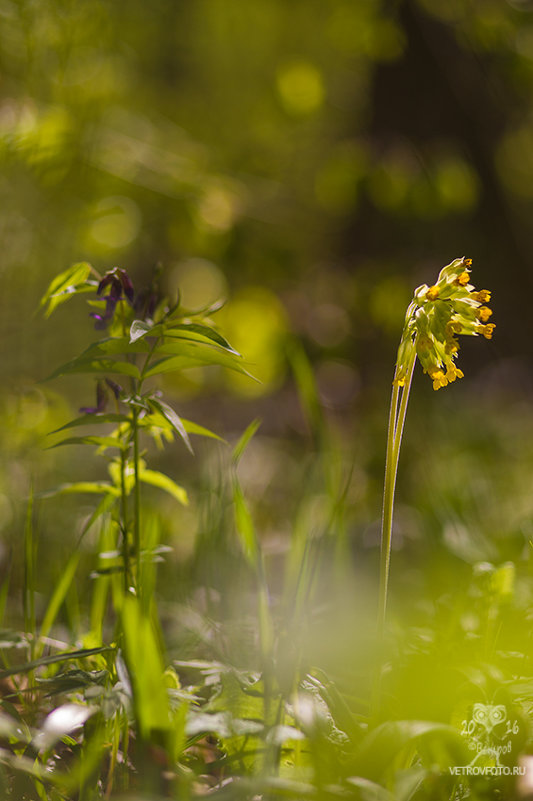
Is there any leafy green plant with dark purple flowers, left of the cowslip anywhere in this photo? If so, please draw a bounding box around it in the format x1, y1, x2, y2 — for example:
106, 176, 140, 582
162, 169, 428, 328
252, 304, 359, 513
41, 263, 249, 591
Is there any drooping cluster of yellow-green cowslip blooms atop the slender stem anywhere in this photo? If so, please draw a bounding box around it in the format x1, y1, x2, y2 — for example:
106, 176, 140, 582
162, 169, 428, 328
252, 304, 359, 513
394, 258, 496, 390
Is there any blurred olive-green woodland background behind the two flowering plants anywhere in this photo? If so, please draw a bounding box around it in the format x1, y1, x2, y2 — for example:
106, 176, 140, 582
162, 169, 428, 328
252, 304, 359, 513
0, 0, 533, 640
